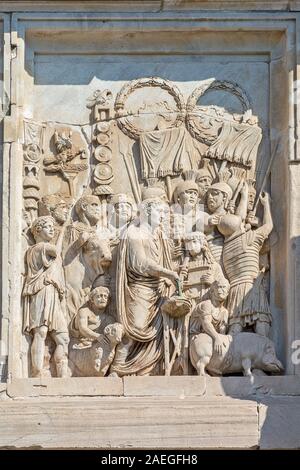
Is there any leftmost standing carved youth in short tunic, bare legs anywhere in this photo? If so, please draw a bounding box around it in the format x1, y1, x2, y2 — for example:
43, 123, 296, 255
23, 216, 69, 377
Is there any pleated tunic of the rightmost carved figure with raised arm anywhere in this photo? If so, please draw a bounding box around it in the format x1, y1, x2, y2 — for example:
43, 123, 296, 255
223, 226, 271, 326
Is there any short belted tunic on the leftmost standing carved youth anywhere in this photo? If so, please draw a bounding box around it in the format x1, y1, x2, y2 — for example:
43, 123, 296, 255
23, 242, 68, 332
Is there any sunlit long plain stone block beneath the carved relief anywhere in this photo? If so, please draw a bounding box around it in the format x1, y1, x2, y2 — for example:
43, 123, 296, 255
0, 397, 258, 449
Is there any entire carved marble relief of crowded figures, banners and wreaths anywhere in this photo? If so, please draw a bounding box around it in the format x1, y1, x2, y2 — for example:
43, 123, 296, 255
22, 77, 283, 377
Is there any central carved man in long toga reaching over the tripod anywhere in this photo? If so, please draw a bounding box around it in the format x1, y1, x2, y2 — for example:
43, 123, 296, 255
111, 198, 179, 375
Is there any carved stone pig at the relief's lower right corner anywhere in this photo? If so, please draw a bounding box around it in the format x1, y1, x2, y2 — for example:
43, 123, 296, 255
190, 333, 283, 377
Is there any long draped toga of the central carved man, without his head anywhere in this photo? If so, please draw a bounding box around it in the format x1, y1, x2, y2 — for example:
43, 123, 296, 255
113, 224, 171, 375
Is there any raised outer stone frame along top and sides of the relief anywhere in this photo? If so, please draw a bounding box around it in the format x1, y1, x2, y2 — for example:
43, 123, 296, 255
2, 12, 300, 381
